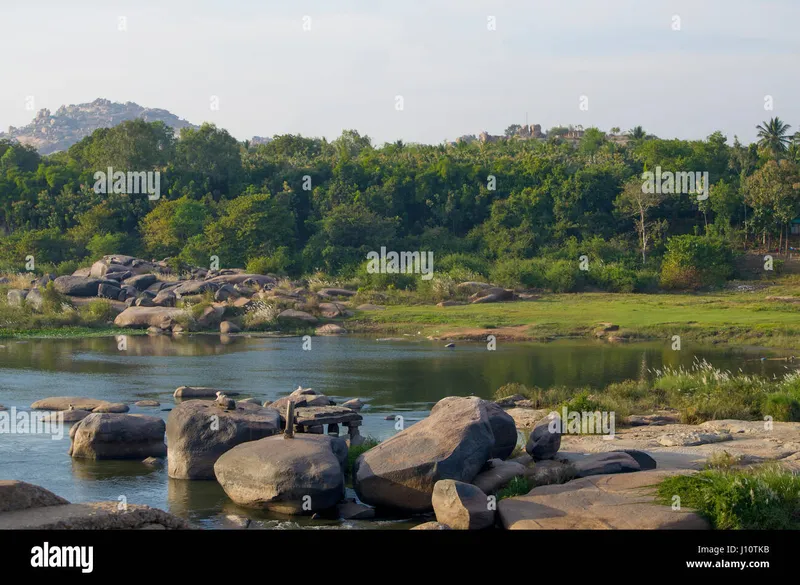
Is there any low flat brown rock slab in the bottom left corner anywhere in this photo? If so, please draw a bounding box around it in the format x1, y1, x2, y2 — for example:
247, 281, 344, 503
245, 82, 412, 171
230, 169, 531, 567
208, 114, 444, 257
0, 501, 190, 530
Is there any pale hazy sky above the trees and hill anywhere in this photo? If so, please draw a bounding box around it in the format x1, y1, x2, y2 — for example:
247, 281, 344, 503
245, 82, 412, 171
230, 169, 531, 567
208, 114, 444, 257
0, 0, 800, 143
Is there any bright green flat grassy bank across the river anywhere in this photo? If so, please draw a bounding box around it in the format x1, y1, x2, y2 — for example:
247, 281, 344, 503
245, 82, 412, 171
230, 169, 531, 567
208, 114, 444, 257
348, 285, 800, 349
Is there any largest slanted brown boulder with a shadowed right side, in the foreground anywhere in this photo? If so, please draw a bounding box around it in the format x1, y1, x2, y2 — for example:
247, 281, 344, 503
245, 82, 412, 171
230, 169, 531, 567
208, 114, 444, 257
353, 397, 494, 512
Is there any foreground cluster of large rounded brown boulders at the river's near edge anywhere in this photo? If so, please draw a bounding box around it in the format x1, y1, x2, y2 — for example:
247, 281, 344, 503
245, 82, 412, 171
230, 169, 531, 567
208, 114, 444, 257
6, 386, 728, 530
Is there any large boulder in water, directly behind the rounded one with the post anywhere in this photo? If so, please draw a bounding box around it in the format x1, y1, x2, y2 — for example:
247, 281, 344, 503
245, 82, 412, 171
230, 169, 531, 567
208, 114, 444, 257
167, 400, 281, 479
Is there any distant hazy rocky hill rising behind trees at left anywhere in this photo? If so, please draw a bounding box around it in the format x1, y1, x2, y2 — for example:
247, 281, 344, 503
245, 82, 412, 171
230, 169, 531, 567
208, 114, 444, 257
0, 99, 197, 154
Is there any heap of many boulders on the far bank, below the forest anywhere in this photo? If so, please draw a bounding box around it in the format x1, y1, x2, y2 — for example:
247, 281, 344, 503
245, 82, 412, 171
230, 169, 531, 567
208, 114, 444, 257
7, 254, 356, 335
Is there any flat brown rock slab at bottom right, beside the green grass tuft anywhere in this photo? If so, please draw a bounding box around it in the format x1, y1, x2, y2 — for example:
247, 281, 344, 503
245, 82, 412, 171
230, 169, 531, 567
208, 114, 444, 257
497, 470, 710, 530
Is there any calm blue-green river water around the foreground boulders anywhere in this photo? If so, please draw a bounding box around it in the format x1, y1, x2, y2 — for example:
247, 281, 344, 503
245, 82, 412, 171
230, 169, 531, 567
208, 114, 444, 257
0, 335, 787, 528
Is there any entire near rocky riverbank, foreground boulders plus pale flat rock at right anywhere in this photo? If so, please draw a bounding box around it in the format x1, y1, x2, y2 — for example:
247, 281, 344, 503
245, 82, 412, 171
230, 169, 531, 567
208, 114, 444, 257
0, 387, 800, 529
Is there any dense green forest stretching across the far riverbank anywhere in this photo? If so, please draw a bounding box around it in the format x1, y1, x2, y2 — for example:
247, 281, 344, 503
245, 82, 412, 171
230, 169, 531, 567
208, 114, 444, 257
0, 118, 800, 291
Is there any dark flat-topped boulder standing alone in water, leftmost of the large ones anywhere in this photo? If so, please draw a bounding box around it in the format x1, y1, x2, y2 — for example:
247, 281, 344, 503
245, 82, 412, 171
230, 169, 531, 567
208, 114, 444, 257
69, 413, 167, 460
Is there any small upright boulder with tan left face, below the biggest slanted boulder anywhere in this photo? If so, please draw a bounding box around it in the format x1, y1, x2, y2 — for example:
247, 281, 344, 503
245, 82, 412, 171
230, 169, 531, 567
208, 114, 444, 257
431, 479, 494, 530
